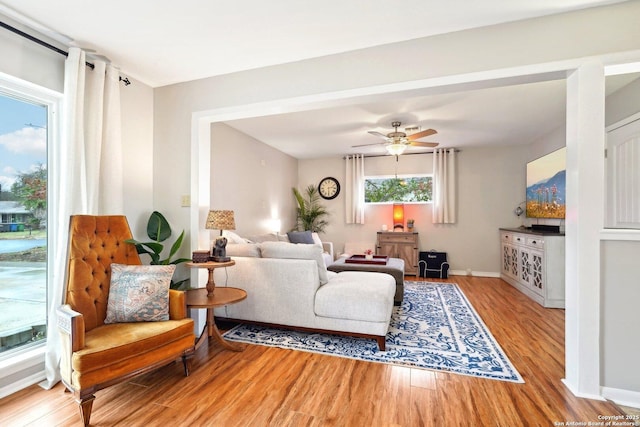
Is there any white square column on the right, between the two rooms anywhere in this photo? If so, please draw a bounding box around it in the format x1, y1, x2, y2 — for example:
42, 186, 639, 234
564, 63, 605, 398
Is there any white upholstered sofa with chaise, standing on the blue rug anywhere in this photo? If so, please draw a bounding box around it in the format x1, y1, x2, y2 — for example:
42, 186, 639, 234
214, 242, 396, 351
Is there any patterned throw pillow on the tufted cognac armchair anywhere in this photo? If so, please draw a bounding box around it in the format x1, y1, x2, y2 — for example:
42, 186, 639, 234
104, 264, 176, 323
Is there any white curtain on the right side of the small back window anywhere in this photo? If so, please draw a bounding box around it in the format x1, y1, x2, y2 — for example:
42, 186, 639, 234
433, 148, 456, 224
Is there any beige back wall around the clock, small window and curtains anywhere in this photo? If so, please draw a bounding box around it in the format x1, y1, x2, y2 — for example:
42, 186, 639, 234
298, 146, 527, 276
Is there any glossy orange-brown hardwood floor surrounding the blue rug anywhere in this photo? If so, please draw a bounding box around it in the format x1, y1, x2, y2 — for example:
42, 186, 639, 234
0, 276, 622, 426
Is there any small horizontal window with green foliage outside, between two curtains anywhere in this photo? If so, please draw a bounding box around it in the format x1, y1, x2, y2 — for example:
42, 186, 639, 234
364, 175, 432, 203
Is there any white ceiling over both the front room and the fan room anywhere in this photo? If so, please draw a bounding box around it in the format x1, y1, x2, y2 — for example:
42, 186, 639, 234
0, 0, 629, 158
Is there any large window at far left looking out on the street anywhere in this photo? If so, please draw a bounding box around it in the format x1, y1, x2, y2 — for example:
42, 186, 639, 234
0, 89, 50, 358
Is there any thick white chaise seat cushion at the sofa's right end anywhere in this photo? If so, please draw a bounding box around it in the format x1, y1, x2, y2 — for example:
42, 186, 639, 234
314, 271, 396, 322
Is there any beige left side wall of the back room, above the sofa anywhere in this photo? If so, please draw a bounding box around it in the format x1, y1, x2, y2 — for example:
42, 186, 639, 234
211, 123, 298, 237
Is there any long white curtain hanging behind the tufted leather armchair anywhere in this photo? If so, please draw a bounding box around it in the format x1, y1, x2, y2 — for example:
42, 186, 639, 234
40, 48, 123, 388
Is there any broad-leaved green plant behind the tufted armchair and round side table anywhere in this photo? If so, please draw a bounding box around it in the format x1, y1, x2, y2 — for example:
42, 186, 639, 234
126, 211, 191, 289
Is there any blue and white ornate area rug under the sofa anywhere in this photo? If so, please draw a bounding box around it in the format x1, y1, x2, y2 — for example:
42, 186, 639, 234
224, 281, 524, 383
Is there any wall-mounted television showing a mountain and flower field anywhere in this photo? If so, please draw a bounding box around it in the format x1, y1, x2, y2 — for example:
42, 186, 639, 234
526, 148, 567, 219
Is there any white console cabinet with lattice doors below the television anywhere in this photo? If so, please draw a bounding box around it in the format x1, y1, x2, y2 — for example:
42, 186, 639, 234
500, 228, 565, 308
